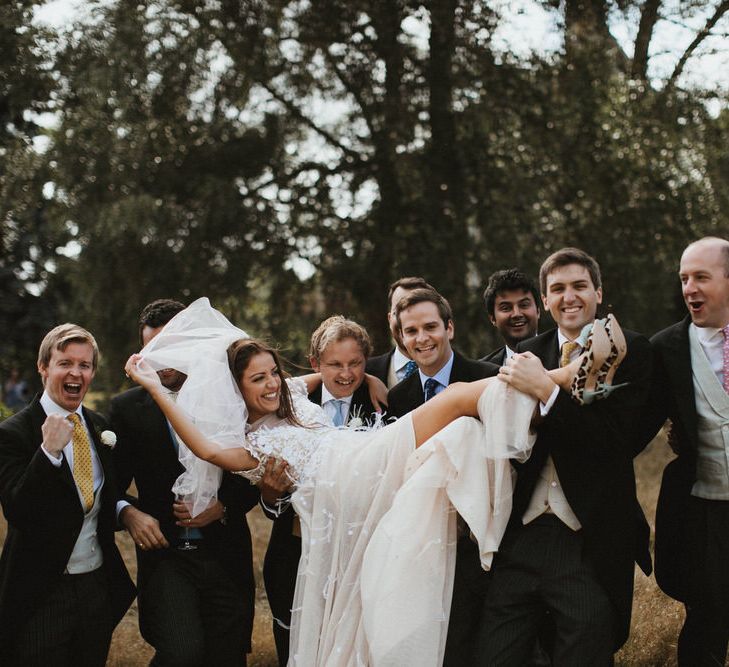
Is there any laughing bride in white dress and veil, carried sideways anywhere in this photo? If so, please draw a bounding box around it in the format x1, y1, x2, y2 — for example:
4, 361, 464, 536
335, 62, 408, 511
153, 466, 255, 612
126, 298, 620, 667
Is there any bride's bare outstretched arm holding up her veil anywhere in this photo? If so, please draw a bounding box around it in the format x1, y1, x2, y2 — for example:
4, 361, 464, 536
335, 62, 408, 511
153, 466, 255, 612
124, 354, 258, 470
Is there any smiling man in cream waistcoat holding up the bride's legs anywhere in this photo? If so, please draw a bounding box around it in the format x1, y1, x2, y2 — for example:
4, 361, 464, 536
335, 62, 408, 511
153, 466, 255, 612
477, 248, 651, 665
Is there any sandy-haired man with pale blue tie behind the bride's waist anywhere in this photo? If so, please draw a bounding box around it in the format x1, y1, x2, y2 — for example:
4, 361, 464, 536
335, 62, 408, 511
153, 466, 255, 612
261, 315, 375, 666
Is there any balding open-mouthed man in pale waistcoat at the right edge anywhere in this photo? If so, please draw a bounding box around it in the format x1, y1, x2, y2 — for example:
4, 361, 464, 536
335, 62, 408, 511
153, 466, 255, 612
643, 237, 729, 667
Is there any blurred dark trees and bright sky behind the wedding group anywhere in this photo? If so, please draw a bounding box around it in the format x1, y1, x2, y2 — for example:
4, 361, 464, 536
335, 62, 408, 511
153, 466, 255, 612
0, 0, 729, 664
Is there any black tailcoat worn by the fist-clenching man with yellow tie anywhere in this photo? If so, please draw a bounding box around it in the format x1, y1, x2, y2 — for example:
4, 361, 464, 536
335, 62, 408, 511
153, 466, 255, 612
0, 396, 134, 654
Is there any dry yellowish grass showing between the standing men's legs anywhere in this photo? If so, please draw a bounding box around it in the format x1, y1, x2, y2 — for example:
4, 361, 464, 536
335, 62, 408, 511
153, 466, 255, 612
0, 435, 720, 667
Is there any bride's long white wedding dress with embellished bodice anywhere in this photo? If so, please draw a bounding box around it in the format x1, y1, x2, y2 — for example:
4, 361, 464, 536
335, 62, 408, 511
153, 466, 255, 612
143, 299, 535, 667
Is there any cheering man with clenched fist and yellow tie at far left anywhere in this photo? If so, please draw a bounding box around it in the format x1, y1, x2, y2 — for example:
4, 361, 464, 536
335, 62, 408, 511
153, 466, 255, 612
0, 324, 134, 667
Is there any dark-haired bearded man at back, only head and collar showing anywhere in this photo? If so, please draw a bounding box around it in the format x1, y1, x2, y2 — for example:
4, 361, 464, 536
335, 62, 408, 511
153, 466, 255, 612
481, 269, 539, 366
